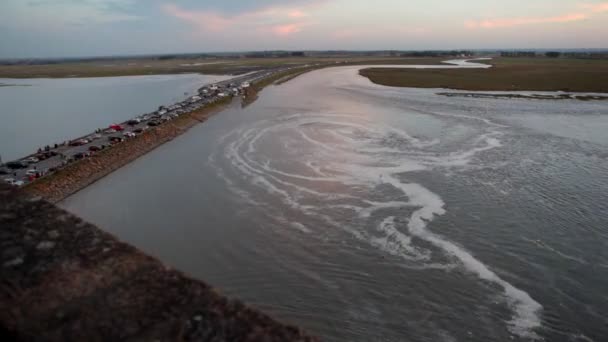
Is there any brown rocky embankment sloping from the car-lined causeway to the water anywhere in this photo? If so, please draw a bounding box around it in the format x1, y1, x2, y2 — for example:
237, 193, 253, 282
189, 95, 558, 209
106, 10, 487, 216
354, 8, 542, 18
23, 98, 230, 203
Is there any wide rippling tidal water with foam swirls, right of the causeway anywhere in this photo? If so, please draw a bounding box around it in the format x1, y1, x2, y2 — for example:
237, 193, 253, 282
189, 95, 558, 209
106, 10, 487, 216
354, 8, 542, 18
62, 62, 608, 342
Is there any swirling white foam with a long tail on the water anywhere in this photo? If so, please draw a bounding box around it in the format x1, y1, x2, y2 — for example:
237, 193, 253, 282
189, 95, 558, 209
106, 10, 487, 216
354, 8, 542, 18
211, 108, 542, 338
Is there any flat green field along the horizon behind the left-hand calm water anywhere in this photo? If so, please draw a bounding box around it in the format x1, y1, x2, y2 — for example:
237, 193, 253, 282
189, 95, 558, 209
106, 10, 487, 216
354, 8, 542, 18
0, 57, 441, 78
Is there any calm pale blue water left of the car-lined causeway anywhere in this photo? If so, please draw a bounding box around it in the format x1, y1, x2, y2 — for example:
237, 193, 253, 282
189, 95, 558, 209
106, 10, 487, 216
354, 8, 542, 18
0, 74, 229, 160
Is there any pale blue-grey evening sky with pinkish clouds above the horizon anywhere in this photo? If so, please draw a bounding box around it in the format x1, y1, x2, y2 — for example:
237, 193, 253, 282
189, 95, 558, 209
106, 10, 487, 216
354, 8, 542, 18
0, 0, 608, 58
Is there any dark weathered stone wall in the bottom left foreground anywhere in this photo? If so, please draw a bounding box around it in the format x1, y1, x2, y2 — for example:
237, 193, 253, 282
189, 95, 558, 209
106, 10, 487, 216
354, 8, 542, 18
0, 183, 316, 342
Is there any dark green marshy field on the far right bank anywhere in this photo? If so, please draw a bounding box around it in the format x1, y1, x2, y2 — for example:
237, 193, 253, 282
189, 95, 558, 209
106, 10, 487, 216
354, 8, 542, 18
361, 58, 608, 93
